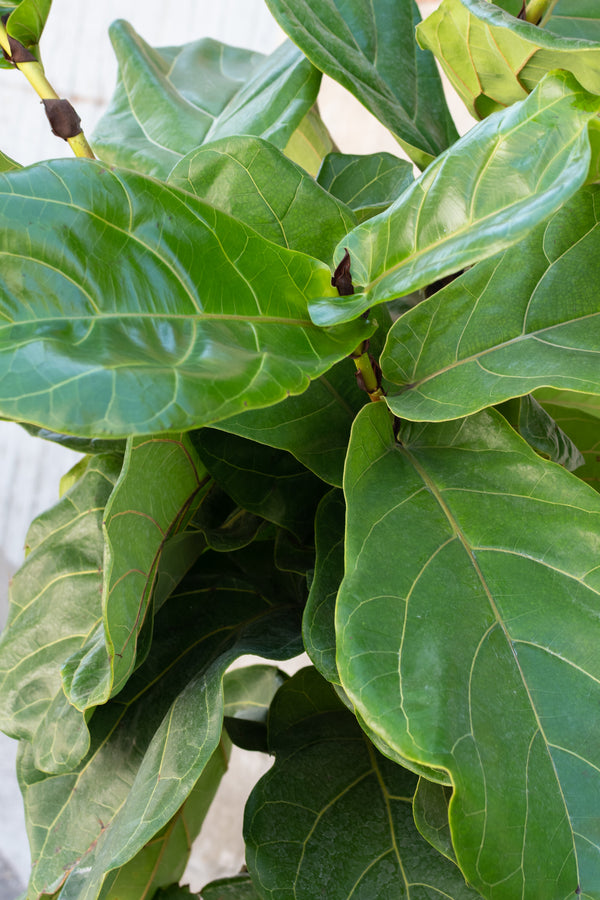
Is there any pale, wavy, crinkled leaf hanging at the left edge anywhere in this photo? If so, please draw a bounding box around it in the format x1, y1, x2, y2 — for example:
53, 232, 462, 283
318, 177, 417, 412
0, 454, 121, 772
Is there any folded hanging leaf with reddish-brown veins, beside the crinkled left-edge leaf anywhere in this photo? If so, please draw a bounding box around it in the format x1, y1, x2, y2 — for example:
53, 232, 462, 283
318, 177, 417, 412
63, 434, 210, 709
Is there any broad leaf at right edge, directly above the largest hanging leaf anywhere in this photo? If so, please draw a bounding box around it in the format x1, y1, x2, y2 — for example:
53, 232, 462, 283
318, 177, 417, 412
381, 185, 600, 421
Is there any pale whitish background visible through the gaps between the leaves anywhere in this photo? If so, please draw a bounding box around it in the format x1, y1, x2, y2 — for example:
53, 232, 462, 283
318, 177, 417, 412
0, 0, 473, 900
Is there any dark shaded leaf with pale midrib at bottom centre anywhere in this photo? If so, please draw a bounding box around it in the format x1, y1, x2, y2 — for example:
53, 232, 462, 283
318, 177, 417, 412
244, 669, 478, 900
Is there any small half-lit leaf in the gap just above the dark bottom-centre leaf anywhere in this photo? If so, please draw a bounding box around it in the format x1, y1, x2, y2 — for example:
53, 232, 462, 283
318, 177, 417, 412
223, 665, 288, 753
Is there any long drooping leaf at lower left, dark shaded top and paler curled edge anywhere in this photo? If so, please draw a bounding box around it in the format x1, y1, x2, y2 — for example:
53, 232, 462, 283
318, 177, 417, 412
20, 542, 305, 900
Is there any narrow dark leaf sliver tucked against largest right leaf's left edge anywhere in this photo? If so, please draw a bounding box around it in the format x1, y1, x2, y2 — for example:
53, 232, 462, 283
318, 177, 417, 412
302, 490, 346, 684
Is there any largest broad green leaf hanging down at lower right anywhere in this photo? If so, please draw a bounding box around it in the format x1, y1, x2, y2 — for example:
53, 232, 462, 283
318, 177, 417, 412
336, 404, 600, 900
